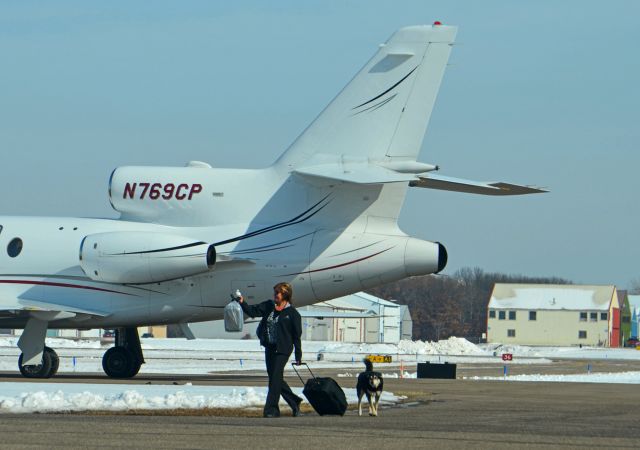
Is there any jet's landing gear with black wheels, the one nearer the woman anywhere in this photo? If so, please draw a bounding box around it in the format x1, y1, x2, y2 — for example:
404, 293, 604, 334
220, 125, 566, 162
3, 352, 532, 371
102, 328, 144, 378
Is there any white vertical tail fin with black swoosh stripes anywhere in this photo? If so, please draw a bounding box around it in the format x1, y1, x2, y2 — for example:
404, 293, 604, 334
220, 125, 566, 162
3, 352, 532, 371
277, 25, 457, 169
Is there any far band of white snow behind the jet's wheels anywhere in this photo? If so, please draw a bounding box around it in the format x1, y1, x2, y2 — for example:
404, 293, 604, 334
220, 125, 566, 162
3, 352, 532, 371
0, 337, 640, 375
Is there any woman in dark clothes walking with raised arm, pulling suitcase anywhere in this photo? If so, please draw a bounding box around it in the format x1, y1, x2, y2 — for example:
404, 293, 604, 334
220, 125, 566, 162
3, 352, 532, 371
238, 283, 302, 417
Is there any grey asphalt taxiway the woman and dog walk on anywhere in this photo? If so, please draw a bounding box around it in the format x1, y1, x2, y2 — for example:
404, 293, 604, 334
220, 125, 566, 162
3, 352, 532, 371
0, 361, 640, 449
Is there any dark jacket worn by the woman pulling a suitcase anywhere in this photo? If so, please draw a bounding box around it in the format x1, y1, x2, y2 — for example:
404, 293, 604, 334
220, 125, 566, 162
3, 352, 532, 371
240, 300, 302, 361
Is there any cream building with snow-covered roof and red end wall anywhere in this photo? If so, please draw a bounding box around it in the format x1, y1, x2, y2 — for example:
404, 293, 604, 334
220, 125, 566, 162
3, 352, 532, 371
487, 283, 621, 347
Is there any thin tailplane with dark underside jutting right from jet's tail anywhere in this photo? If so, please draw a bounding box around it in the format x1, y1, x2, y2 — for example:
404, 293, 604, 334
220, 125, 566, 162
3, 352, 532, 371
409, 174, 548, 195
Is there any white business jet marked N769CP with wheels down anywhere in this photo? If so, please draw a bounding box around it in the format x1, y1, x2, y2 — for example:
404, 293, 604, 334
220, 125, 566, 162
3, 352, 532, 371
0, 22, 544, 378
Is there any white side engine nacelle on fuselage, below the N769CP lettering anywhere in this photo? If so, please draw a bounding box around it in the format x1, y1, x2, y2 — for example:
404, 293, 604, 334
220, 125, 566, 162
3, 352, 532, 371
80, 231, 216, 284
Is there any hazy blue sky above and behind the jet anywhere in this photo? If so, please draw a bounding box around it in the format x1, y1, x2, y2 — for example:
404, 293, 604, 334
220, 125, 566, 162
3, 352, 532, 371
0, 0, 640, 287
